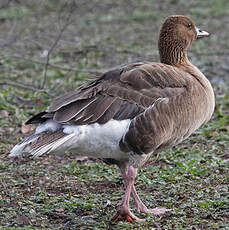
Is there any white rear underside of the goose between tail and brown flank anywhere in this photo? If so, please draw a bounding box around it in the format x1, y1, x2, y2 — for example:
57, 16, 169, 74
61, 119, 130, 160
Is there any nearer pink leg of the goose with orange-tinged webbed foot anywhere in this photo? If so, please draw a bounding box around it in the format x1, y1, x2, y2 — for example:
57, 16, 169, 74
111, 166, 143, 222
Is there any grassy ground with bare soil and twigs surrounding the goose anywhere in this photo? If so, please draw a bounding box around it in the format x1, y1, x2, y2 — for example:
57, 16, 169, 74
0, 0, 229, 230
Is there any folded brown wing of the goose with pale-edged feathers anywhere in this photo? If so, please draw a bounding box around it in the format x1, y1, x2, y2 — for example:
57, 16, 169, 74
27, 62, 187, 125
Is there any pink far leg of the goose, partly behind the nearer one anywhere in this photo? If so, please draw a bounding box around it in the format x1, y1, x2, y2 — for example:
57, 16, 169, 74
132, 185, 170, 215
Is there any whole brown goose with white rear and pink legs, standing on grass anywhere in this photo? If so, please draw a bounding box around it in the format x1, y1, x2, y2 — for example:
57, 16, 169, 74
9, 15, 215, 221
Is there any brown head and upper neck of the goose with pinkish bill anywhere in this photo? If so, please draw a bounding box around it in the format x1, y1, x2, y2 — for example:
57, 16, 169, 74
158, 15, 209, 66
